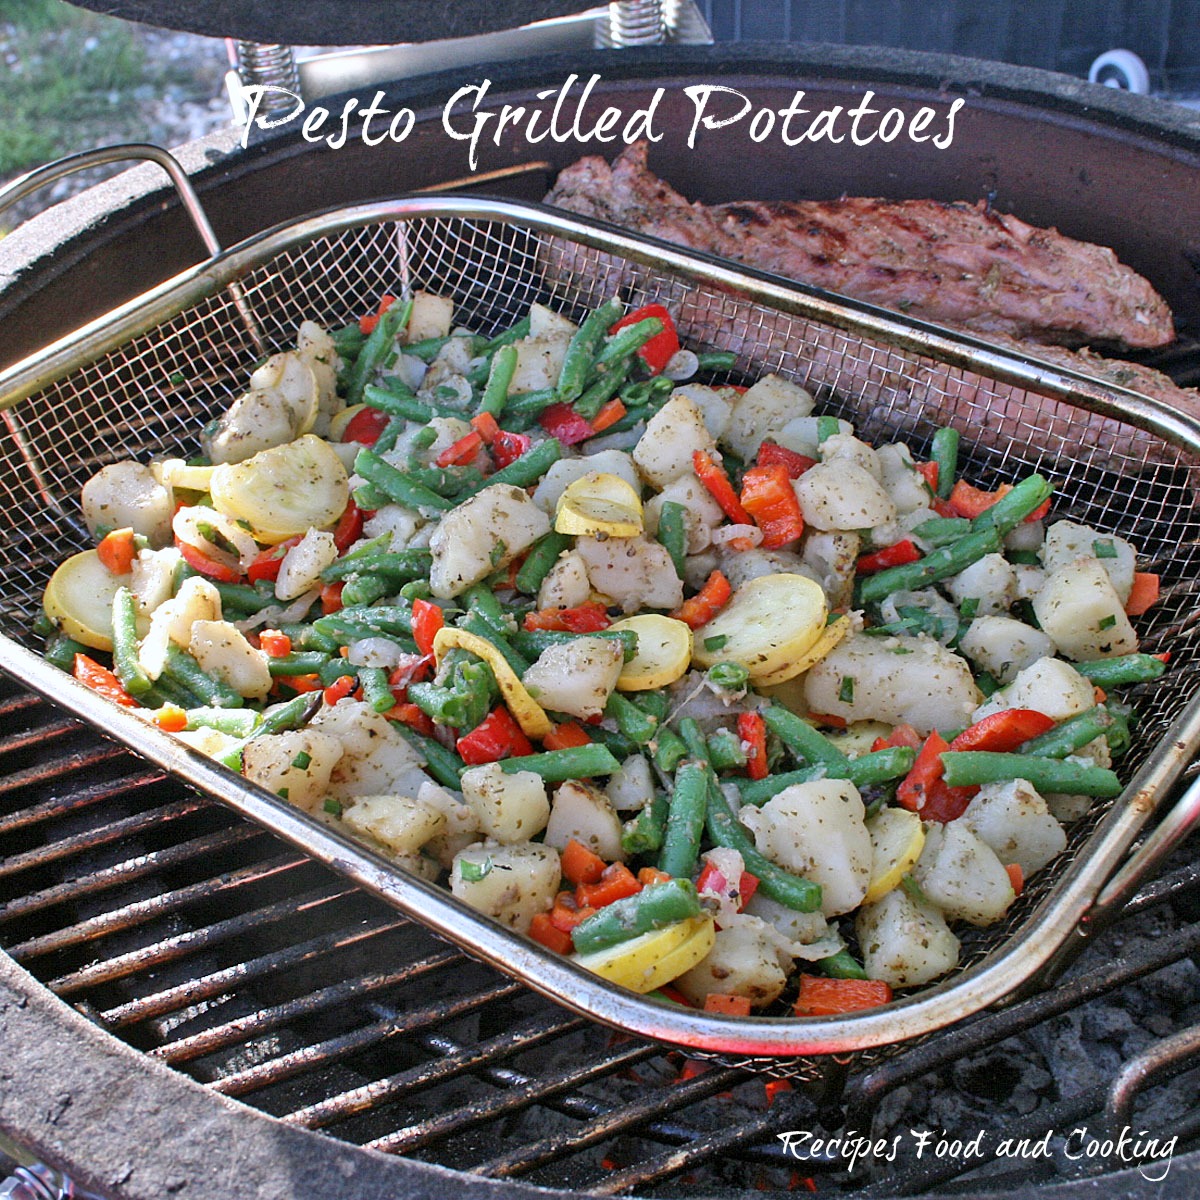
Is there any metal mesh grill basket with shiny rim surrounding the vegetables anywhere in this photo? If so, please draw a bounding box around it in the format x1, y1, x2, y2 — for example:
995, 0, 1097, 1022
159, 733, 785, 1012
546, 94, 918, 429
0, 187, 1200, 1073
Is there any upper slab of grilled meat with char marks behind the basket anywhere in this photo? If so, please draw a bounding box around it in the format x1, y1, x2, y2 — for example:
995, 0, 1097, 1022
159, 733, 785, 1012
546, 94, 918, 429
546, 143, 1175, 347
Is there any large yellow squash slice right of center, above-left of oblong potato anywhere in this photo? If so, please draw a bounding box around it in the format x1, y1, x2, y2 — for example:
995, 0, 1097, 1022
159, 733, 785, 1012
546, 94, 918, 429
694, 574, 828, 683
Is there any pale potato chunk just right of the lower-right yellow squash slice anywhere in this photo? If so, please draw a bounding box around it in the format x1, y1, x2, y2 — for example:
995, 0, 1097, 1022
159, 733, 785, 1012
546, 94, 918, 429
912, 818, 1016, 925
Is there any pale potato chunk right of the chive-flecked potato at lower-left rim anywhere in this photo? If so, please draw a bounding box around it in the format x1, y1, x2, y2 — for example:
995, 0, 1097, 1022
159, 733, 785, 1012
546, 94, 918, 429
311, 698, 428, 800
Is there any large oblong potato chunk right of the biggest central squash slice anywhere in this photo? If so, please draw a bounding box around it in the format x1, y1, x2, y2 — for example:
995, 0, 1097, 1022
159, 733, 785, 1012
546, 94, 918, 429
804, 635, 980, 733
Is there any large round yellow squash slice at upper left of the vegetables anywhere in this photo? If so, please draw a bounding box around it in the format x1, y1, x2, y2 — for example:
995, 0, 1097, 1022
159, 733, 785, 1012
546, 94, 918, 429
209, 433, 350, 545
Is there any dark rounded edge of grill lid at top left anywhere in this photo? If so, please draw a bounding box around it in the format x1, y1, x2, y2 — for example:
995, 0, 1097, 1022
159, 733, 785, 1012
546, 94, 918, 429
62, 0, 588, 46
